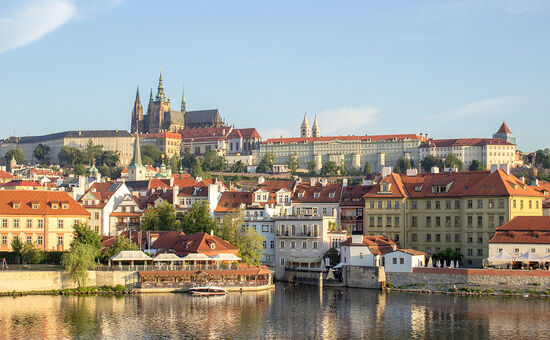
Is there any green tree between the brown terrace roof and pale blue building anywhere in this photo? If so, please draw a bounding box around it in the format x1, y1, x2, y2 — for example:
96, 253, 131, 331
217, 213, 265, 265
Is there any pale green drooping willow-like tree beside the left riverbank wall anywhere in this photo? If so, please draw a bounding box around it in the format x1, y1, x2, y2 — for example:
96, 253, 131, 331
61, 243, 96, 287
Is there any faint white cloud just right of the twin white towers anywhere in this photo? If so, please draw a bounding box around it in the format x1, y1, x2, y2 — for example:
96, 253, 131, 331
316, 106, 380, 136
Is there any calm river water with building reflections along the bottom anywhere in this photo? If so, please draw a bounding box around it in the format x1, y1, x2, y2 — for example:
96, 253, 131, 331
0, 284, 550, 340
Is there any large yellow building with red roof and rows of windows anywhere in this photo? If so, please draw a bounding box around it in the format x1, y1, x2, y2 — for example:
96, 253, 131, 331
364, 170, 544, 267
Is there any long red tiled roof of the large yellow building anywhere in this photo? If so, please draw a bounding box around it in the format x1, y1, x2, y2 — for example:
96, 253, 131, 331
365, 170, 543, 198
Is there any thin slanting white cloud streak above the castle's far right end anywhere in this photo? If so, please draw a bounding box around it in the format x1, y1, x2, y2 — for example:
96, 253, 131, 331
424, 96, 517, 121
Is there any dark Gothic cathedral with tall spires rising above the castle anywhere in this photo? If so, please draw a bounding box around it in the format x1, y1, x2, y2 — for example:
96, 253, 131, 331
131, 74, 225, 133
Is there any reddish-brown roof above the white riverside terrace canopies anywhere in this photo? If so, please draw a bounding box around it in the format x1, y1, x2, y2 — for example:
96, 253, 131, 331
153, 232, 238, 255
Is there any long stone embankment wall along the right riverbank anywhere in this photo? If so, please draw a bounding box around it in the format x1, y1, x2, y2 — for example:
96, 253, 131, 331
386, 268, 550, 288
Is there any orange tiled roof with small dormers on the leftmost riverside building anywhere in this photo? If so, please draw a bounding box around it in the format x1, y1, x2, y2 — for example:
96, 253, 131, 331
0, 190, 90, 217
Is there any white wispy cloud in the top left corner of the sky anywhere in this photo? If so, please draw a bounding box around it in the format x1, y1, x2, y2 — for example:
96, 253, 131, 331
0, 0, 122, 53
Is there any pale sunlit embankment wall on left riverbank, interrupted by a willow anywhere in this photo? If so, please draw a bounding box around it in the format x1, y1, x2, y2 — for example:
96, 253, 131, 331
0, 270, 138, 292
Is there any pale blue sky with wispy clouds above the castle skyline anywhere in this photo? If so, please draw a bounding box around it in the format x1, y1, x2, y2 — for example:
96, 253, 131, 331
0, 0, 550, 151
